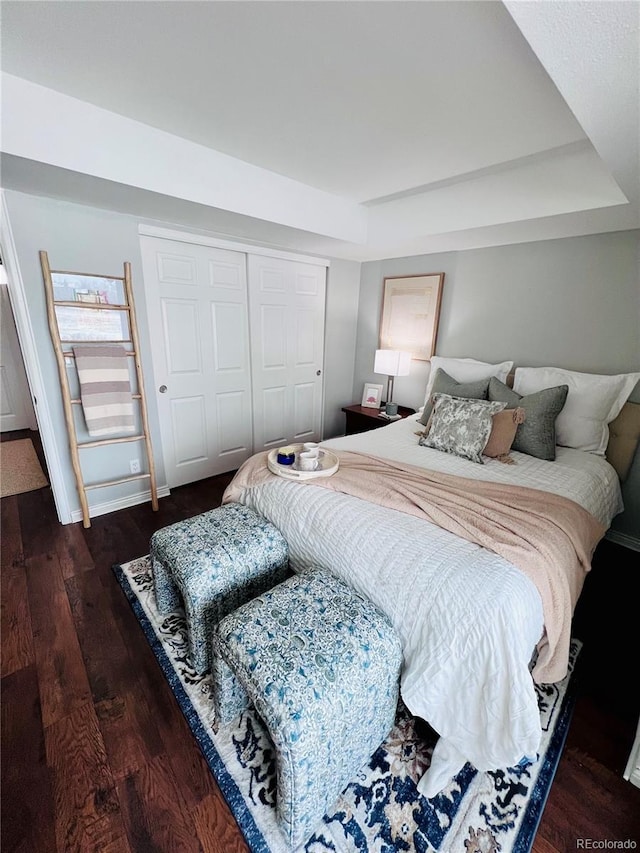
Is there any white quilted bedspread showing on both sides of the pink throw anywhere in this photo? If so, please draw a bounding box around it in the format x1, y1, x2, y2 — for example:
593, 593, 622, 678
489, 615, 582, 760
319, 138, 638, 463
229, 418, 622, 796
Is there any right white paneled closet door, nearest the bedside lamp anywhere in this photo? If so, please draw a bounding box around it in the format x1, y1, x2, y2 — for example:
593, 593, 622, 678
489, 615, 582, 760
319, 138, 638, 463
248, 255, 326, 453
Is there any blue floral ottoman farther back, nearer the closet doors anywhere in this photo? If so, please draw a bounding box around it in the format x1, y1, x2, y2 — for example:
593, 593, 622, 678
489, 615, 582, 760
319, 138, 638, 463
151, 504, 289, 673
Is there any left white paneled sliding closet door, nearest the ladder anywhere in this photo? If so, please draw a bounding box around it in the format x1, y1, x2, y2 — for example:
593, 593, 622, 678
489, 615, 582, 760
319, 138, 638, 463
140, 237, 252, 487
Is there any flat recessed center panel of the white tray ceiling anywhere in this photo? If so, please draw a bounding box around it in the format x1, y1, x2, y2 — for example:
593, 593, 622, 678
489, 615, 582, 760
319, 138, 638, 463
2, 0, 584, 201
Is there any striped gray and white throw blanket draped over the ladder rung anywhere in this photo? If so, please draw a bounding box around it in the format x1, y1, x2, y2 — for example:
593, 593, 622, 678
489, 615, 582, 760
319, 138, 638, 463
73, 344, 135, 438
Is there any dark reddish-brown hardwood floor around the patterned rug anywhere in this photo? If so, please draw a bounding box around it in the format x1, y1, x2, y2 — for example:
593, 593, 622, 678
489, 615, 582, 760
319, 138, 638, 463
0, 433, 640, 853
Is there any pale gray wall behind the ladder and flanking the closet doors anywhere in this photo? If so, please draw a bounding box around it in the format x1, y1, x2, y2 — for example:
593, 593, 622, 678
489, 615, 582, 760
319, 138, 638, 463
5, 191, 360, 511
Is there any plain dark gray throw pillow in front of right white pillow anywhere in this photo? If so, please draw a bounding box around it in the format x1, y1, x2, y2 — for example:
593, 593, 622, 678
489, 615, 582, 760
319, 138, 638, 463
489, 376, 569, 462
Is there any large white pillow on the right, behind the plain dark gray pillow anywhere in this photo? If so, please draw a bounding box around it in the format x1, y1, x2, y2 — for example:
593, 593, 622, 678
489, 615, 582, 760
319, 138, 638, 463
513, 367, 640, 456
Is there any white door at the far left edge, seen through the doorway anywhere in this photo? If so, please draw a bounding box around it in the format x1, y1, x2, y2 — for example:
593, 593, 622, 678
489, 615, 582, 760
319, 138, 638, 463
0, 284, 36, 432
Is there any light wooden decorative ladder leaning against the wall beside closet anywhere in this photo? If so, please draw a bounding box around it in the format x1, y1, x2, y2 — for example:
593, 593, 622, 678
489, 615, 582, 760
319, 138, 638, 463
40, 251, 158, 527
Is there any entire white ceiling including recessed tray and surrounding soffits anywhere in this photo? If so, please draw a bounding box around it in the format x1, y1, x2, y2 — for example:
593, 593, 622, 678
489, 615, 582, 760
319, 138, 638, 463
1, 0, 640, 259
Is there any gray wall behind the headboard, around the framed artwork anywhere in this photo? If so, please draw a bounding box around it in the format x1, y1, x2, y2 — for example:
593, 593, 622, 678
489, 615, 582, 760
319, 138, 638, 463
353, 231, 640, 539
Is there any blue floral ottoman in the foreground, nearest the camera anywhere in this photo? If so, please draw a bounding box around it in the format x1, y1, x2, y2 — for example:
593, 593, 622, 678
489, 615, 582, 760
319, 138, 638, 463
214, 570, 402, 848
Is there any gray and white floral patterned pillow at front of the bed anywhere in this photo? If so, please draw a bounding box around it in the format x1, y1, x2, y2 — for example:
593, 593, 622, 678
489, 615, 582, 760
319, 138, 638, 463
419, 394, 507, 465
